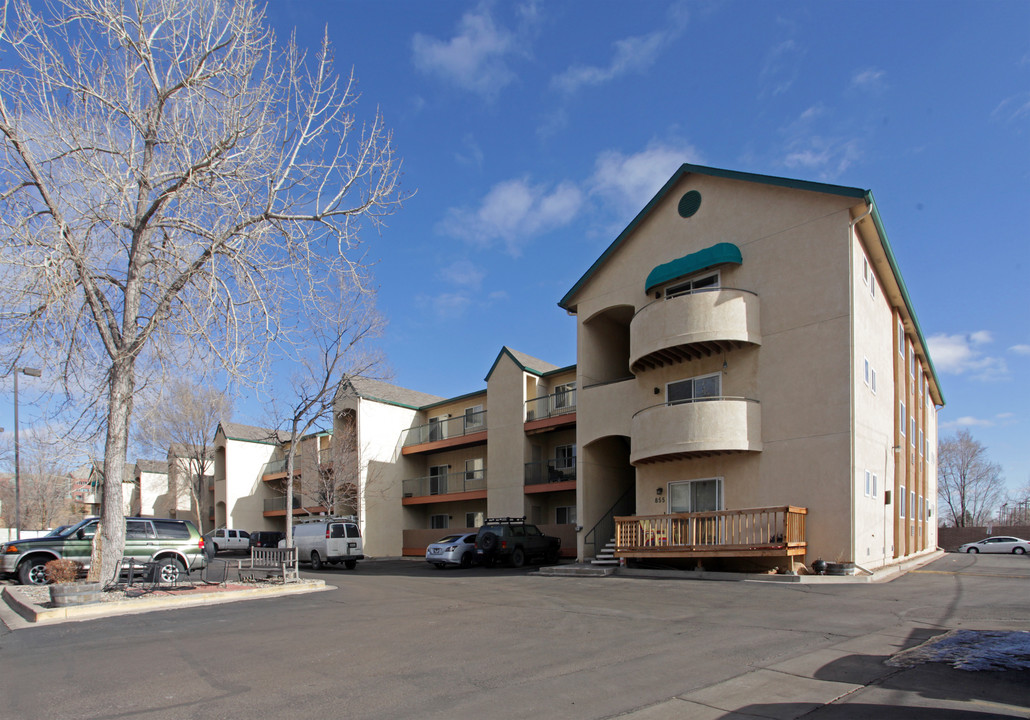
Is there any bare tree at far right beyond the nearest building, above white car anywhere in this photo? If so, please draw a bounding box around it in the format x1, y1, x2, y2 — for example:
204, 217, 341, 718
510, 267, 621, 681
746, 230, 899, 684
937, 430, 1004, 527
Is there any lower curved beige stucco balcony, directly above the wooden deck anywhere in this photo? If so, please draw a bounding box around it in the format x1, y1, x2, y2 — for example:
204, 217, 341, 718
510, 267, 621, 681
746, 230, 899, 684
629, 397, 762, 465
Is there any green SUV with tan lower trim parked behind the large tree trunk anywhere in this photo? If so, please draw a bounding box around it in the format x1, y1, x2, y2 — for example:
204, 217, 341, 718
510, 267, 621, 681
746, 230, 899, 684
0, 517, 207, 585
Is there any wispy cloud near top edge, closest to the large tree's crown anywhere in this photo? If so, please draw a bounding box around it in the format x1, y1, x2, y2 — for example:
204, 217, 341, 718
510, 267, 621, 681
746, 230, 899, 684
412, 7, 520, 97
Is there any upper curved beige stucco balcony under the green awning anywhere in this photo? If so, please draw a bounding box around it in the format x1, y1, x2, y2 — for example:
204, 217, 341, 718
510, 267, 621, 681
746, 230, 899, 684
629, 287, 762, 373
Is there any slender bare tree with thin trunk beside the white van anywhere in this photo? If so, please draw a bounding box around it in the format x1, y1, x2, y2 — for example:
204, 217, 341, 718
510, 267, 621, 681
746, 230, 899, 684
281, 292, 383, 545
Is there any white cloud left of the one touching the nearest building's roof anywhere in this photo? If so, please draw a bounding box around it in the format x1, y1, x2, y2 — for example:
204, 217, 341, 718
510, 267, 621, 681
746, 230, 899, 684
439, 178, 583, 256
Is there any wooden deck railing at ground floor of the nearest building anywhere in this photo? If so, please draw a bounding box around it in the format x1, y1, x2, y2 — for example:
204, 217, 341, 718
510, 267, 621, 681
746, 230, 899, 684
615, 505, 809, 557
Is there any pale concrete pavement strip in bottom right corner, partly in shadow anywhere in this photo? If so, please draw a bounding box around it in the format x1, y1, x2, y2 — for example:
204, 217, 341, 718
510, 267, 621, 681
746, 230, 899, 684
620, 628, 1030, 720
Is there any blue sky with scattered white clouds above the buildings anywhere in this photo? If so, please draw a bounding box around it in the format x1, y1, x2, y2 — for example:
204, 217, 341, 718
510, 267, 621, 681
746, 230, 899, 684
0, 0, 1030, 500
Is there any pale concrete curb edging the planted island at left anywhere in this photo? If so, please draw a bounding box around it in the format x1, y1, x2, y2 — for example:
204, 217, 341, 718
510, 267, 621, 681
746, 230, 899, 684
2, 580, 335, 624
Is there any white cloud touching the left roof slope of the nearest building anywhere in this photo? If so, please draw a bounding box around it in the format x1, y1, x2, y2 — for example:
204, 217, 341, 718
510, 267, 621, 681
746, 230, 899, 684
589, 142, 700, 214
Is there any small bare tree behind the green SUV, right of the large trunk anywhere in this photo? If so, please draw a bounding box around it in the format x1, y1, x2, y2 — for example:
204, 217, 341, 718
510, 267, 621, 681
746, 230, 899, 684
139, 378, 233, 533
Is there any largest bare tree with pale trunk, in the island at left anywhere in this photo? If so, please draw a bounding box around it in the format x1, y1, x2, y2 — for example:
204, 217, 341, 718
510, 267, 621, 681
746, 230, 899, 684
0, 0, 403, 580
